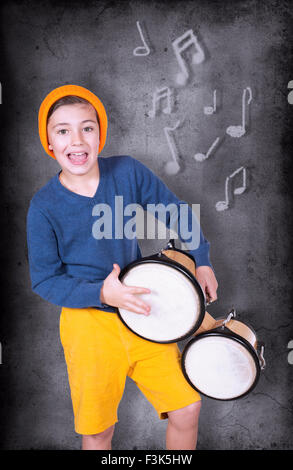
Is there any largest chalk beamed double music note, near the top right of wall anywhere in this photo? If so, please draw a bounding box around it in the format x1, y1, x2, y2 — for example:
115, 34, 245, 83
172, 29, 205, 85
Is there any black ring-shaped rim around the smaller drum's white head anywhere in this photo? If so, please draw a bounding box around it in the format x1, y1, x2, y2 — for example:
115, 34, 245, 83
181, 327, 261, 401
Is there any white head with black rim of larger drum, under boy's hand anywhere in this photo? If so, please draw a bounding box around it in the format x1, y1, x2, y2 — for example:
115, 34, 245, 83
119, 262, 204, 343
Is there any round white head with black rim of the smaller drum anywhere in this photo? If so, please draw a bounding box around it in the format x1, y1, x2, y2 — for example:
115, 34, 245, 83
182, 333, 260, 400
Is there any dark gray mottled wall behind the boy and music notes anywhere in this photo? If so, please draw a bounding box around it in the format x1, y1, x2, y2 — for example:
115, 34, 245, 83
0, 0, 293, 449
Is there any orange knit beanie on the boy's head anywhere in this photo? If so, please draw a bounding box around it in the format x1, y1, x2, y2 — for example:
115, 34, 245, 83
39, 85, 108, 158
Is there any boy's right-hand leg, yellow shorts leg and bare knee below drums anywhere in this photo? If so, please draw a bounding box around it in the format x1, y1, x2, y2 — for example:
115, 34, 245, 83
120, 324, 201, 450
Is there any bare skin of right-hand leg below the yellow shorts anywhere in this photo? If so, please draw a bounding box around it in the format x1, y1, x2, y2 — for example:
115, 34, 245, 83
166, 401, 201, 450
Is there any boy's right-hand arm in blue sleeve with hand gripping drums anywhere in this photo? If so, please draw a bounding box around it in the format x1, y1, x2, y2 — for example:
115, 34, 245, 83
133, 159, 218, 302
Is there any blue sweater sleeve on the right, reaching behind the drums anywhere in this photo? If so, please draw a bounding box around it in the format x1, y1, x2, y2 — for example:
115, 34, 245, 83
133, 159, 213, 269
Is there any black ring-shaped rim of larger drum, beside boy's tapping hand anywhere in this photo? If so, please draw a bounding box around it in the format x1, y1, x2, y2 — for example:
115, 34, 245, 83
116, 255, 205, 344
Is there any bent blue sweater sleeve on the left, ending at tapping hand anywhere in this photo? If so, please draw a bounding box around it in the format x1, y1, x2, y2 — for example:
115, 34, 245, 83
27, 203, 108, 308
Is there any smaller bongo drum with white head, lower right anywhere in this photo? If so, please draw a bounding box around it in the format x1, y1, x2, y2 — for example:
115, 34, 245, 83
181, 309, 265, 400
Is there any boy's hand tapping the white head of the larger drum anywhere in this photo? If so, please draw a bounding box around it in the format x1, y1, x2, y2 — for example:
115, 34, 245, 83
101, 264, 151, 315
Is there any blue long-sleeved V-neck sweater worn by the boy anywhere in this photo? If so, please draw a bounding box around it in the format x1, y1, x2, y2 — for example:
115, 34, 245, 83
27, 156, 211, 312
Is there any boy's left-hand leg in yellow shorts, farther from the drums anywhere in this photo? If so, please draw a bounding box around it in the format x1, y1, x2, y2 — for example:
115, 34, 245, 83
60, 308, 129, 444
